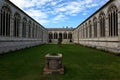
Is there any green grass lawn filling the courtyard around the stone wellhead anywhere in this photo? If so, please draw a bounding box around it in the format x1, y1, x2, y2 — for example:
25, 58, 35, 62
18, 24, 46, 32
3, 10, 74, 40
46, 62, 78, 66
0, 44, 120, 80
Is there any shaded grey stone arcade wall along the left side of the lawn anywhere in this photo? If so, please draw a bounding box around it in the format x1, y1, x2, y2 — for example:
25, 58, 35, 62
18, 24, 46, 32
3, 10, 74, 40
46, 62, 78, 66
0, 0, 48, 54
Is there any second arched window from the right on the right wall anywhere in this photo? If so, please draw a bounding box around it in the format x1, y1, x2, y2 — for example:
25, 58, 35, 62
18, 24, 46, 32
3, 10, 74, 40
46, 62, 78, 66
99, 12, 105, 37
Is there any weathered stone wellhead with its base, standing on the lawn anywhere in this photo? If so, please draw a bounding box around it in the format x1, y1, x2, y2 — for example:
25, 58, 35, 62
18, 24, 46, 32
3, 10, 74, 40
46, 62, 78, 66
44, 54, 64, 74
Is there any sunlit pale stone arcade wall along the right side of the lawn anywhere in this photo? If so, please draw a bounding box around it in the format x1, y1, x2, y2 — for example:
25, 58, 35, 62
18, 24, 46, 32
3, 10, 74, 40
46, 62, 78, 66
73, 0, 120, 53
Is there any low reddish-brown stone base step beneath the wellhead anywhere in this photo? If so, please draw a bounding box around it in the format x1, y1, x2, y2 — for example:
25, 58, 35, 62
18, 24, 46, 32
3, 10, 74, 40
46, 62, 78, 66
44, 67, 64, 74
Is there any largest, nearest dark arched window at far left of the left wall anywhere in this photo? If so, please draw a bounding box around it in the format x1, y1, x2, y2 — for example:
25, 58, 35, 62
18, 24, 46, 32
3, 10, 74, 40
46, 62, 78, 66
0, 6, 11, 36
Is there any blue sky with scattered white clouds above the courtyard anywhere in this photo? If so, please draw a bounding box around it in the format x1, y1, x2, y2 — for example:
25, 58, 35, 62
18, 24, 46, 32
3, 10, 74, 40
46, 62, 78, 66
10, 0, 109, 28
